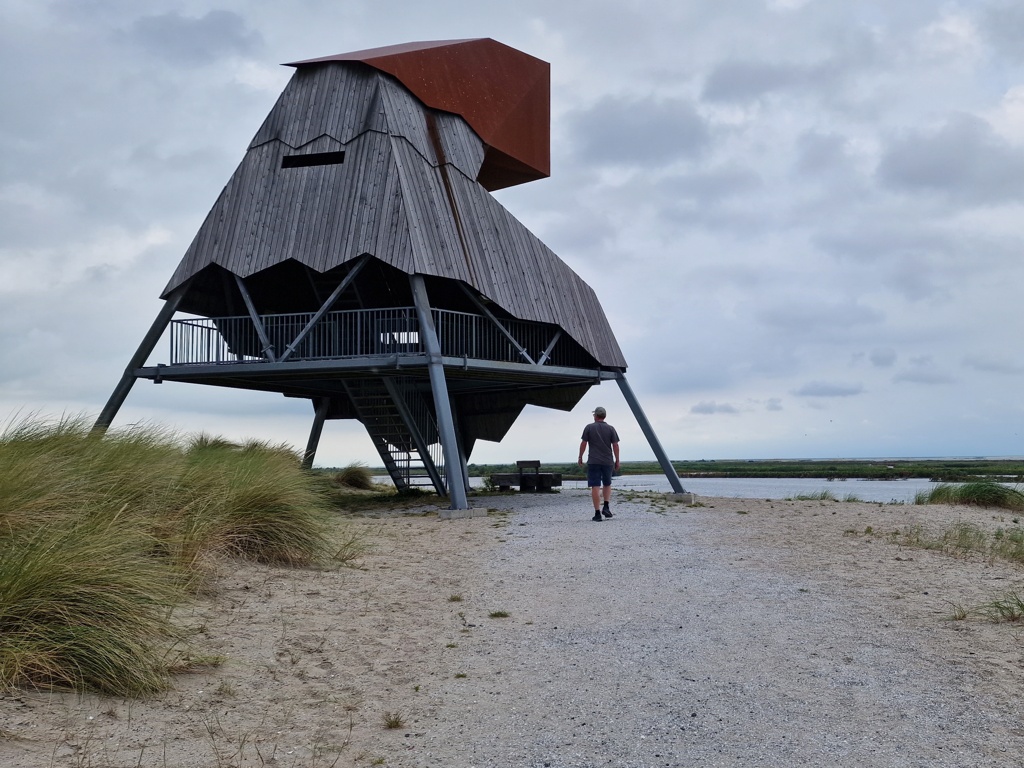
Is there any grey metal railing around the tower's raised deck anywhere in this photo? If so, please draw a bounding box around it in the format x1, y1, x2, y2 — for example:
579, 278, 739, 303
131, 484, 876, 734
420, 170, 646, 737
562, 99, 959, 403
170, 307, 594, 368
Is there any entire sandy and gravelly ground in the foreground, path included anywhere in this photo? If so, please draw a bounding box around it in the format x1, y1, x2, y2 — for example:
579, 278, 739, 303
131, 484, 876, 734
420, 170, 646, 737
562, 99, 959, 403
0, 490, 1024, 768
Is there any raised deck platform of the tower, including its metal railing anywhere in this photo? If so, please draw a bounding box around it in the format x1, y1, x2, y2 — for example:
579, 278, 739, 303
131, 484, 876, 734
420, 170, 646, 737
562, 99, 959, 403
135, 307, 614, 396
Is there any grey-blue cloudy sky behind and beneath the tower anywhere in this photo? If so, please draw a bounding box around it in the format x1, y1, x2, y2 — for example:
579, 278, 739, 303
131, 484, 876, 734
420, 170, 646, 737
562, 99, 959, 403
0, 0, 1024, 466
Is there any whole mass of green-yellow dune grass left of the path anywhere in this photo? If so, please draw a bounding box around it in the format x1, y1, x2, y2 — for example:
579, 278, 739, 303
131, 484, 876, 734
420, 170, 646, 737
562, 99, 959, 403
0, 418, 344, 695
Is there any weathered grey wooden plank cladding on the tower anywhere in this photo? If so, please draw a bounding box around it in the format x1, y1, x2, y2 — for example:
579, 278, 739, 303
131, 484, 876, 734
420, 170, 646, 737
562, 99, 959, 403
164, 61, 626, 370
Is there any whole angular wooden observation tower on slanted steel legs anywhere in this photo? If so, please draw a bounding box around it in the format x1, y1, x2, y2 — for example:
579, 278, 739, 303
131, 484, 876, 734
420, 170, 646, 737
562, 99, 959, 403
96, 39, 682, 509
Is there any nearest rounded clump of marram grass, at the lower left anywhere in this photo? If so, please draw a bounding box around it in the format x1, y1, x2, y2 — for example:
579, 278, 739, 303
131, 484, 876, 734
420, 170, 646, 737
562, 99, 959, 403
0, 514, 183, 695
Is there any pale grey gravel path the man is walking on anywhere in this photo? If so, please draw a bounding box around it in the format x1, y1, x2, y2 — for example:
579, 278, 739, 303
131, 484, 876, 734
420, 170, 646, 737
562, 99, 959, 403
400, 492, 1024, 768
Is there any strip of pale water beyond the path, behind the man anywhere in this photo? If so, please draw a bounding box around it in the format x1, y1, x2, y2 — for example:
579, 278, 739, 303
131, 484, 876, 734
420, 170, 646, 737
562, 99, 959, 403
495, 475, 938, 504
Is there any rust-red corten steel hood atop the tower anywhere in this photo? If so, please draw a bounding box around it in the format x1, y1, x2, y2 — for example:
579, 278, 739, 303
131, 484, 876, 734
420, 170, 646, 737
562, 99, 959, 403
288, 38, 551, 191
